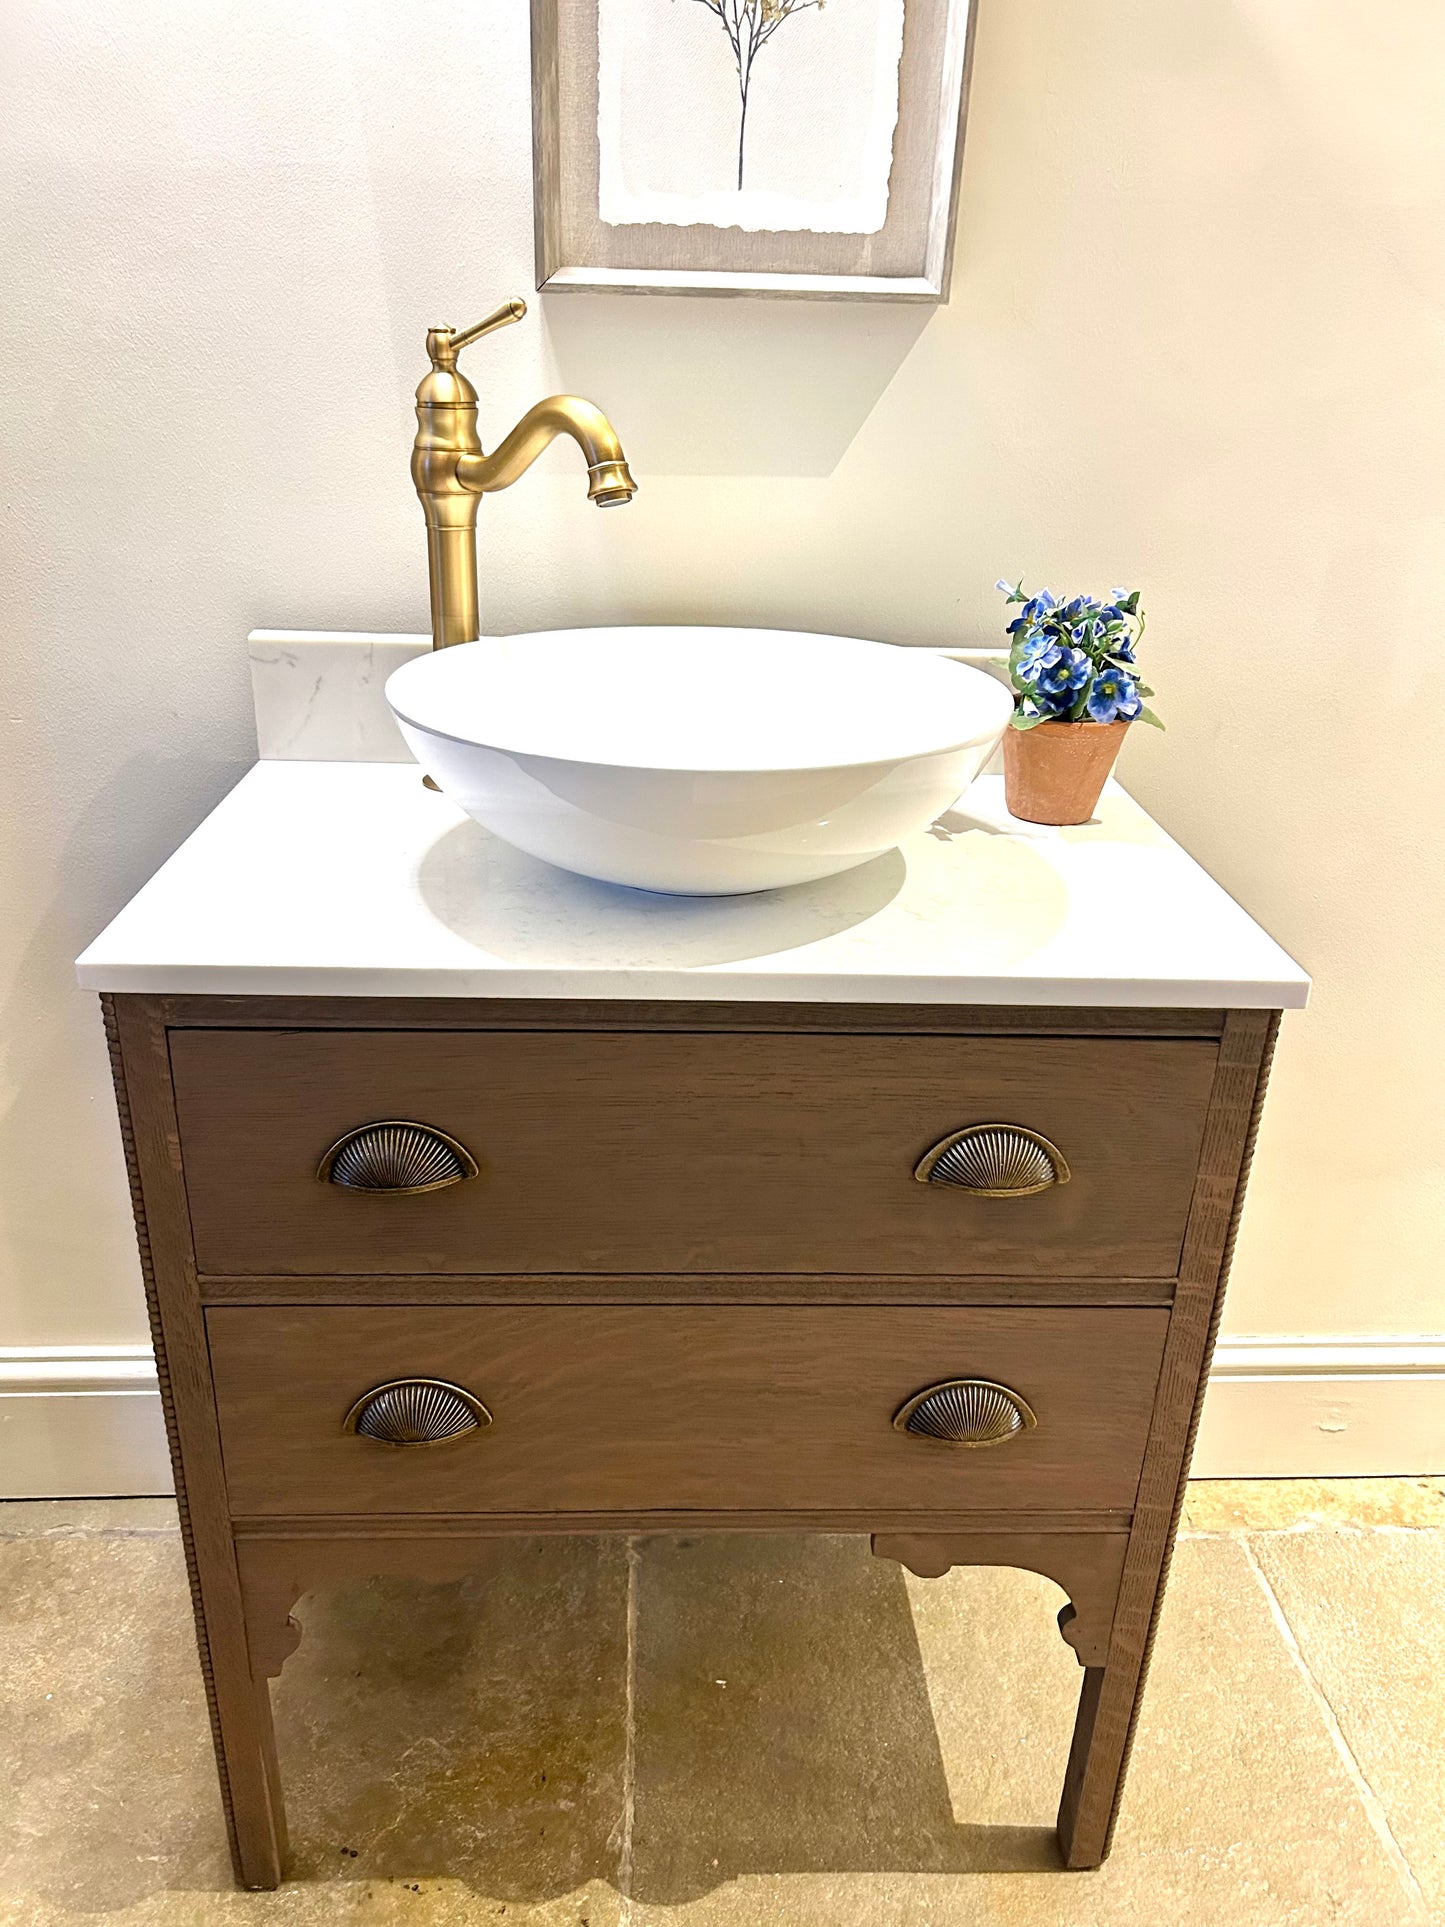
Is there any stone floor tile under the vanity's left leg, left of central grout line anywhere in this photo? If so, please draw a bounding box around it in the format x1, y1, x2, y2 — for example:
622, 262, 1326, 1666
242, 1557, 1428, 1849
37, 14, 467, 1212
0, 1509, 626, 1927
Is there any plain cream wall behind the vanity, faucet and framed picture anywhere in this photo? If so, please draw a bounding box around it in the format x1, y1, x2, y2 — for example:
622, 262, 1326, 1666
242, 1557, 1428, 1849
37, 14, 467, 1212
0, 0, 1445, 1387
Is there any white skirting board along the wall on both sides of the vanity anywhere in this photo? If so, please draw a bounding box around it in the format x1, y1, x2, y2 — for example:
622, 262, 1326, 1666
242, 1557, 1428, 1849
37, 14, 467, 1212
0, 1335, 1445, 1499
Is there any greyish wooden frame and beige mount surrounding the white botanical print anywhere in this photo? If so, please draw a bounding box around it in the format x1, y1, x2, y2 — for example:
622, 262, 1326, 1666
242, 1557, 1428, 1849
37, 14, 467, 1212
532, 0, 975, 303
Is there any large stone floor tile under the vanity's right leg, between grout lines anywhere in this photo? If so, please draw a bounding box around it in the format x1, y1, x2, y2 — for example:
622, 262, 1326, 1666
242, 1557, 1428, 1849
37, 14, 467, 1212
632, 1538, 1412, 1927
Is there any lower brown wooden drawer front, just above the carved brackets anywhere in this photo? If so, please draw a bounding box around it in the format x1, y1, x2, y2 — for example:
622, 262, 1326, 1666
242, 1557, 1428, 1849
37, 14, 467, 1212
206, 1307, 1169, 1517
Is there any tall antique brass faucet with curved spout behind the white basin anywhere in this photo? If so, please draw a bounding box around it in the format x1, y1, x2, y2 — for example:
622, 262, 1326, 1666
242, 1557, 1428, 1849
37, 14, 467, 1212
412, 301, 638, 649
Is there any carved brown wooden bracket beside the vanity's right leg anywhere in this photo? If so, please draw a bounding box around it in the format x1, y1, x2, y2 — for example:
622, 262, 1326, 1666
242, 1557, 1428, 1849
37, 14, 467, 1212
873, 1532, 1129, 1667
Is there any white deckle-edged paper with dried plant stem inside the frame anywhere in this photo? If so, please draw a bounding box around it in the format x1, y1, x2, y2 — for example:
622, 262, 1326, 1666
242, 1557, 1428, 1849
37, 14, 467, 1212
597, 0, 904, 233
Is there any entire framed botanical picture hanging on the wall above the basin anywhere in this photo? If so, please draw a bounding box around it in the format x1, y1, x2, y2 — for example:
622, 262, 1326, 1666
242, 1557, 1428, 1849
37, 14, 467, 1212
532, 0, 973, 301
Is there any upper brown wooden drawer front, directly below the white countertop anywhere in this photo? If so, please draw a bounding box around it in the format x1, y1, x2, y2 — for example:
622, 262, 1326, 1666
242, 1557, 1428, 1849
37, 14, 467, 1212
171, 1031, 1216, 1278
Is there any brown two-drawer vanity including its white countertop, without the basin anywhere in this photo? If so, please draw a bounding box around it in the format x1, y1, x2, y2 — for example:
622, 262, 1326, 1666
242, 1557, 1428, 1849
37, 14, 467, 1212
81, 743, 1306, 1887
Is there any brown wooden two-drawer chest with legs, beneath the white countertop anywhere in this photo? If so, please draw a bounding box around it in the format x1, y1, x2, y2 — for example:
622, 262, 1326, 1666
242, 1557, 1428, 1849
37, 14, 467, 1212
104, 996, 1275, 1887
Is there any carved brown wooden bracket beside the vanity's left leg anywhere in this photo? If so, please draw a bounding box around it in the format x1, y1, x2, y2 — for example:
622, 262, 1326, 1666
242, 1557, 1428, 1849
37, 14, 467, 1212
235, 1536, 499, 1678
